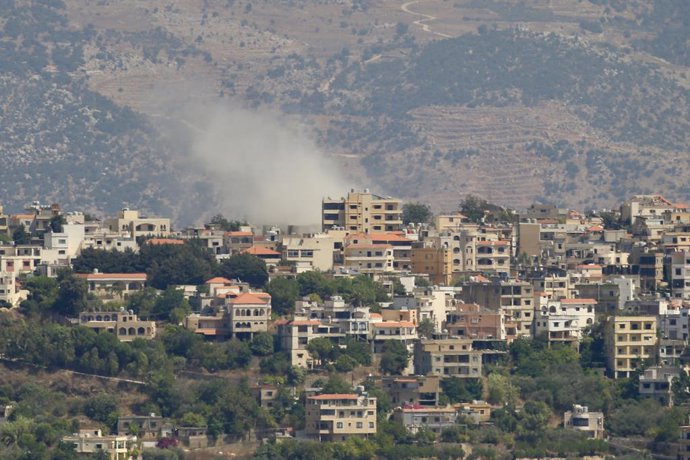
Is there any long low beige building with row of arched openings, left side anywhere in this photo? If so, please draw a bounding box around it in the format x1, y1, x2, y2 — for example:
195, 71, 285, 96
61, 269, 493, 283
79, 310, 156, 342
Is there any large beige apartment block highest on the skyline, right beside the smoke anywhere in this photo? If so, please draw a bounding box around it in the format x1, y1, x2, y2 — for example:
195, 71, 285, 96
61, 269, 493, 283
321, 189, 402, 233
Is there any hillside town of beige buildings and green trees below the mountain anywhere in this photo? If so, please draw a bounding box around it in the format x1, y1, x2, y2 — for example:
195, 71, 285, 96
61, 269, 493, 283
0, 189, 690, 460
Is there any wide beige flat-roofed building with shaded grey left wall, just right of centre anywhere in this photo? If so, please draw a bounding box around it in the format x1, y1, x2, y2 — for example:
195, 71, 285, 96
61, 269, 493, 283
414, 339, 482, 378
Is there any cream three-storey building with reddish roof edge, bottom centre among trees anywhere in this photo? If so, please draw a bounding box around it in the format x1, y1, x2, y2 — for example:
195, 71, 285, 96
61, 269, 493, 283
305, 393, 376, 442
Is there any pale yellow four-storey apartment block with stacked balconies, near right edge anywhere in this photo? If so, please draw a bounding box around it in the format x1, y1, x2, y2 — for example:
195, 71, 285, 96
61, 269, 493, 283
605, 315, 657, 378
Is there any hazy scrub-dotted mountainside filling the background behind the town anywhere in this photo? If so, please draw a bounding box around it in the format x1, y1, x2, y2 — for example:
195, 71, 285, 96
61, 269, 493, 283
0, 0, 690, 223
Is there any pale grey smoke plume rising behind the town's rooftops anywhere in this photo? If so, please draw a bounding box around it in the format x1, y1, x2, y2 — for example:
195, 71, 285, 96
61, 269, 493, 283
163, 103, 348, 225
